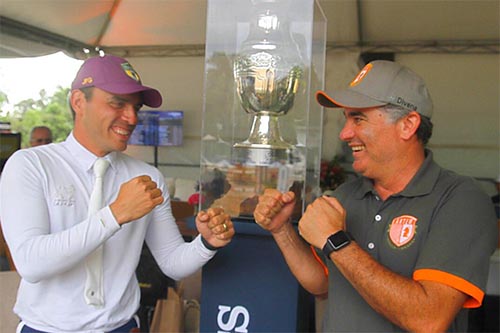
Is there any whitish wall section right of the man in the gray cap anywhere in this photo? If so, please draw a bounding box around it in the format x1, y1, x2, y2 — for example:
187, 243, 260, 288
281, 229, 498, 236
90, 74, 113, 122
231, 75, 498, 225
397, 54, 500, 178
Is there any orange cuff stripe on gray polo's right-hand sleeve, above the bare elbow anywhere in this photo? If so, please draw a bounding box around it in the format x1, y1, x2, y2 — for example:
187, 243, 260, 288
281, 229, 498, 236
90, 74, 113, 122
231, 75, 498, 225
413, 269, 484, 308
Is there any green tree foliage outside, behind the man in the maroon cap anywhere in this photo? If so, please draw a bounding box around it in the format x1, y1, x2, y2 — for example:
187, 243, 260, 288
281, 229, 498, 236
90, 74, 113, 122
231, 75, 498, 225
0, 87, 73, 148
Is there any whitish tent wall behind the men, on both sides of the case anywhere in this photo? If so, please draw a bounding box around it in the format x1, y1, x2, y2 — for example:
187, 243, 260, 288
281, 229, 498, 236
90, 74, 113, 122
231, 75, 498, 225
128, 51, 500, 193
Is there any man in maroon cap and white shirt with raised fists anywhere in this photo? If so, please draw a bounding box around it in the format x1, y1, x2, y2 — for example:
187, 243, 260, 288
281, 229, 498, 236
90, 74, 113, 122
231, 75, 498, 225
0, 55, 234, 333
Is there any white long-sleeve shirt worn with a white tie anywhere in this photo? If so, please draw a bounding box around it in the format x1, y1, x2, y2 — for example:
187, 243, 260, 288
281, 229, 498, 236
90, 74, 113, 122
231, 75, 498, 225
0, 134, 215, 332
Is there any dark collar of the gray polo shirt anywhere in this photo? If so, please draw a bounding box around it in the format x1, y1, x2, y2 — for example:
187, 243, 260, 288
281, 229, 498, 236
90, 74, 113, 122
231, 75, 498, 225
354, 149, 441, 199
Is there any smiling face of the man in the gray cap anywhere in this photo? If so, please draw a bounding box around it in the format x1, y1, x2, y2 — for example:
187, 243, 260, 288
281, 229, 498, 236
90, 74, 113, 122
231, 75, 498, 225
340, 108, 400, 180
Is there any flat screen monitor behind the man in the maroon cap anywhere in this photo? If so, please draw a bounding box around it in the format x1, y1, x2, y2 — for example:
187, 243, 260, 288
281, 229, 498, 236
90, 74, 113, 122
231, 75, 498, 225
128, 111, 184, 146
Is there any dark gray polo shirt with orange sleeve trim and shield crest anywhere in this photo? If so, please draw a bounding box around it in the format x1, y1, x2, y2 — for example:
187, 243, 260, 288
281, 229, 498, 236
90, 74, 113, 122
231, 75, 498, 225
323, 151, 498, 332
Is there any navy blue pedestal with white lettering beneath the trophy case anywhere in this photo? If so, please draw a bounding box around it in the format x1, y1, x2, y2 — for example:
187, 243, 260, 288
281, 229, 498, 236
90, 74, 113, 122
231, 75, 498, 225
198, 219, 314, 333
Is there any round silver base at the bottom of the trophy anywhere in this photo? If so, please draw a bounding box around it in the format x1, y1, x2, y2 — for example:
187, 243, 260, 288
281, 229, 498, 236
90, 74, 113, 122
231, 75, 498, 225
232, 142, 293, 166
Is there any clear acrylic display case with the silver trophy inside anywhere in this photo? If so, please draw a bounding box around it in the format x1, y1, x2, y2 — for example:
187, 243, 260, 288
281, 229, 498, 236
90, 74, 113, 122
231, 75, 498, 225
199, 0, 326, 220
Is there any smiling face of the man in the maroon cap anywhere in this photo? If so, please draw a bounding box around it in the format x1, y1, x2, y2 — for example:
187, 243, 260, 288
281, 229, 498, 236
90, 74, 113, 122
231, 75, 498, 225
71, 88, 142, 156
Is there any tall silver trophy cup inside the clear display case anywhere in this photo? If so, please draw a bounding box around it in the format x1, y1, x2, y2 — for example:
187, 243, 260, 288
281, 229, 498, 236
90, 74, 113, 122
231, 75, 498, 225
233, 3, 303, 165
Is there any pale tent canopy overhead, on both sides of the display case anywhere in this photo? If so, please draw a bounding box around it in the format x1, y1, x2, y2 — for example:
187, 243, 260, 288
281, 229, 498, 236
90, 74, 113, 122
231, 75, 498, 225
0, 0, 500, 58
